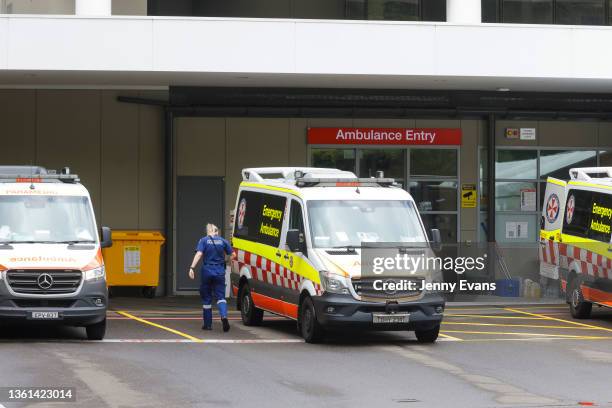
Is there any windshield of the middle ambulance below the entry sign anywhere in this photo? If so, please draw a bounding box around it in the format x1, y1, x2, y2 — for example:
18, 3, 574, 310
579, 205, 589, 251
308, 200, 427, 248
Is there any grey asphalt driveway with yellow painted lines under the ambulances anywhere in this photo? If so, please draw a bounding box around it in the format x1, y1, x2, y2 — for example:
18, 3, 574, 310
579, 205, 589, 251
0, 299, 612, 408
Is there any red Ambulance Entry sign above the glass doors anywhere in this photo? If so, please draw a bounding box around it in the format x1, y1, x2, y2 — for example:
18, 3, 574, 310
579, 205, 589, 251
308, 128, 461, 145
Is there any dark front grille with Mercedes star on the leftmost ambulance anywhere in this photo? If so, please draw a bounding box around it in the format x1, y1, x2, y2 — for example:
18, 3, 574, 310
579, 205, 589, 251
6, 269, 83, 295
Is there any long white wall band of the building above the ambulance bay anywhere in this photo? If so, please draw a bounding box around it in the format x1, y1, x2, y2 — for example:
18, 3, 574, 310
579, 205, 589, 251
0, 15, 612, 81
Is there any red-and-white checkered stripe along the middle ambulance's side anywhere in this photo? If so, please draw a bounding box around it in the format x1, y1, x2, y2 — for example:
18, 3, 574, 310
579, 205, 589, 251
234, 249, 323, 296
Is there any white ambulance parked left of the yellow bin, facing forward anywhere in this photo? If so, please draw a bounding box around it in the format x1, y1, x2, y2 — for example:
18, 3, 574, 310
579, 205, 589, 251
0, 166, 112, 340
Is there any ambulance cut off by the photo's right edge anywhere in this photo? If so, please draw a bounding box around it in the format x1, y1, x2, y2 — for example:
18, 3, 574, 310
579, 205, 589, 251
539, 167, 612, 319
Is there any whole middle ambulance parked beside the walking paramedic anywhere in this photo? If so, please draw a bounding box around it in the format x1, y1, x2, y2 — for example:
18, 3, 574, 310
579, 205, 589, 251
230, 167, 445, 343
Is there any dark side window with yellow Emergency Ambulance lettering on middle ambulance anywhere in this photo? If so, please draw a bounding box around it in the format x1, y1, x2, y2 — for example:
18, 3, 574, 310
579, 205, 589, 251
234, 191, 287, 247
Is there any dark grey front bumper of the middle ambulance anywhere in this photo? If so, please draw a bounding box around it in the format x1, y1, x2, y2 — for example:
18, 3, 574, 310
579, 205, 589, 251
313, 294, 445, 330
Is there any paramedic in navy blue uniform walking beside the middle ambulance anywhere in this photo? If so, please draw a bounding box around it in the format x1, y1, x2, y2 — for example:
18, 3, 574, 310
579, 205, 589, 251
189, 224, 235, 332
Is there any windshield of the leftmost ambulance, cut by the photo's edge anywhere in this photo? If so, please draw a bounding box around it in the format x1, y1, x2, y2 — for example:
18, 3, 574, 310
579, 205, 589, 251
0, 196, 96, 243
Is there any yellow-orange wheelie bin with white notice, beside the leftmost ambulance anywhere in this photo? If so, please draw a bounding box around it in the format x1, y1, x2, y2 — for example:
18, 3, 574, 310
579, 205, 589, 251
102, 231, 165, 299
